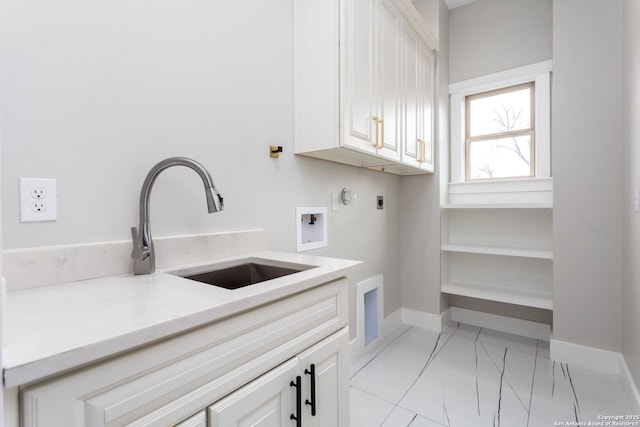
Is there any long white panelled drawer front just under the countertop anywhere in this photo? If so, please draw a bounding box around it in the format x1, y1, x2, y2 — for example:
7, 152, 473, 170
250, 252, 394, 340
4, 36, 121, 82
23, 279, 347, 427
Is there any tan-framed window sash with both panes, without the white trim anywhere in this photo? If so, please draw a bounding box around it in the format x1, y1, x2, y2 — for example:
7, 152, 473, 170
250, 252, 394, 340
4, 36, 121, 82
465, 82, 535, 181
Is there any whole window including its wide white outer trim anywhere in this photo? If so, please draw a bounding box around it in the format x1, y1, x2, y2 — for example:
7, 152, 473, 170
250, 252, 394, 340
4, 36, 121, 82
445, 61, 552, 186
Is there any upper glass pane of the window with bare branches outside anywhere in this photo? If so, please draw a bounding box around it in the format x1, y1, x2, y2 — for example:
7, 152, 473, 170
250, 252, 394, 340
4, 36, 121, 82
468, 86, 532, 137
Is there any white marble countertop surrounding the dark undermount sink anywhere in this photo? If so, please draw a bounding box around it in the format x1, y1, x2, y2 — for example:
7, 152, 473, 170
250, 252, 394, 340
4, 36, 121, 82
3, 252, 360, 387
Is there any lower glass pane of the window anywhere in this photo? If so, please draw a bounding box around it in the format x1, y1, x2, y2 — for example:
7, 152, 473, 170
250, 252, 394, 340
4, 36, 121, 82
469, 135, 531, 179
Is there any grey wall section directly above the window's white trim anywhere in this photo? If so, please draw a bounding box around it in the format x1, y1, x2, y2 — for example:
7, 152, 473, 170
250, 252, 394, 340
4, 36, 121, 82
449, 0, 552, 83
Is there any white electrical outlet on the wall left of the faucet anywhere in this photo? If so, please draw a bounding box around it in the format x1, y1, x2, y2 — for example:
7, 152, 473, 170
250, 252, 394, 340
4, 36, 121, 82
20, 178, 58, 222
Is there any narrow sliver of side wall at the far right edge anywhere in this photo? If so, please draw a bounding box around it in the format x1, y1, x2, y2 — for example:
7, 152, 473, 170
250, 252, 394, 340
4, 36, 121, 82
622, 0, 640, 392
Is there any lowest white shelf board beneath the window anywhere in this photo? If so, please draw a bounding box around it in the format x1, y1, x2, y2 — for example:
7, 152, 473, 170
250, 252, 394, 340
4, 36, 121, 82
441, 282, 553, 310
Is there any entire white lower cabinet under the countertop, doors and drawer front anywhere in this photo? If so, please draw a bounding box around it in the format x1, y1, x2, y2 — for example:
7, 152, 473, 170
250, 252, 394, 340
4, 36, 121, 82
20, 278, 349, 427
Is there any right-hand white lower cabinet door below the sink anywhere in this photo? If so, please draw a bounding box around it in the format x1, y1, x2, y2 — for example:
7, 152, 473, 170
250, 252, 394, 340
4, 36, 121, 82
298, 328, 349, 427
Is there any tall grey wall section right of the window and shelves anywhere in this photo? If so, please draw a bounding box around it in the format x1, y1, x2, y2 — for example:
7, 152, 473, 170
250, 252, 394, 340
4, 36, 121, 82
552, 0, 628, 351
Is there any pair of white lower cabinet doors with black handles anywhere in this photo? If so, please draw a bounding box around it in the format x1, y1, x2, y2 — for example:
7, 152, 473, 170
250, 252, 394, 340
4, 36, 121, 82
209, 329, 348, 427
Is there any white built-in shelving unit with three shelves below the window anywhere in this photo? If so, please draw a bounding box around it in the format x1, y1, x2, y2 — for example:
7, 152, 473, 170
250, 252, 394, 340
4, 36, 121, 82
440, 199, 553, 310
